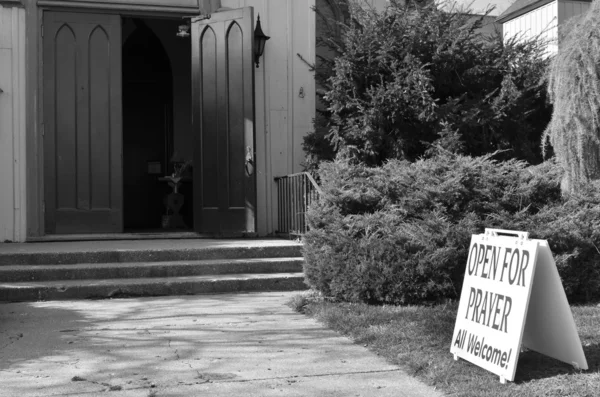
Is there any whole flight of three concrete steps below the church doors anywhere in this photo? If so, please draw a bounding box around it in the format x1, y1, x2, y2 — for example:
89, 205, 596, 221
0, 239, 306, 302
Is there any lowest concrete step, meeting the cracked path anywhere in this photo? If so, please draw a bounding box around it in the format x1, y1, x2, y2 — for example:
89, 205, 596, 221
0, 273, 307, 302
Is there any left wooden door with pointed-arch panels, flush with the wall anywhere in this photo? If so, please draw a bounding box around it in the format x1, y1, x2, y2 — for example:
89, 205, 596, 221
43, 11, 123, 234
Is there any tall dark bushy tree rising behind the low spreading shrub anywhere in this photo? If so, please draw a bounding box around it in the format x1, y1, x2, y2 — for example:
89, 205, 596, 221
305, 0, 550, 165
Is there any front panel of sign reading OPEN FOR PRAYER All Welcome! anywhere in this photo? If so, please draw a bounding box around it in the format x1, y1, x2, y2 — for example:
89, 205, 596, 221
450, 235, 538, 380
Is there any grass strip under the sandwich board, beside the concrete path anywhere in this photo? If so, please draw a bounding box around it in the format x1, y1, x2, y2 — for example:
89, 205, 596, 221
289, 294, 600, 397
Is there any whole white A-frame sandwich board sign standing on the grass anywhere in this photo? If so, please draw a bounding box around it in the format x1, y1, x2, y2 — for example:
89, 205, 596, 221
450, 229, 588, 383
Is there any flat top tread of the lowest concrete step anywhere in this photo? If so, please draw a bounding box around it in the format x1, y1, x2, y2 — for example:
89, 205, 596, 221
0, 272, 304, 289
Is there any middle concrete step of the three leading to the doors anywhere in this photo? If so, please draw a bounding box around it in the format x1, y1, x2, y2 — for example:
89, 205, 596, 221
0, 257, 304, 283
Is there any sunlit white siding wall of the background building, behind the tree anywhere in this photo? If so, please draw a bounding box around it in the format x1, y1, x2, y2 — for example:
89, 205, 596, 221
502, 1, 558, 55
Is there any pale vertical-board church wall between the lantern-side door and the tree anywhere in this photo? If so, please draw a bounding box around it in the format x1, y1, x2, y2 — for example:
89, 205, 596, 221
221, 0, 315, 235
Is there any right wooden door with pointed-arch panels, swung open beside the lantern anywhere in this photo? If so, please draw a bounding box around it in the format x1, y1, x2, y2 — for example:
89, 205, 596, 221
192, 7, 256, 235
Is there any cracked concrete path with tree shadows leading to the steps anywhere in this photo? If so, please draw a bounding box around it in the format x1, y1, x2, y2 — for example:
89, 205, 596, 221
0, 292, 441, 397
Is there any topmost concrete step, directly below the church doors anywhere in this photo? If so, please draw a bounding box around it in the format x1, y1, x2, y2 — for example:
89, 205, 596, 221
0, 239, 302, 266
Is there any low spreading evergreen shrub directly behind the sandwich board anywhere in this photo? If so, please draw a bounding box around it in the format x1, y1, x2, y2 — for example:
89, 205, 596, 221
304, 153, 600, 304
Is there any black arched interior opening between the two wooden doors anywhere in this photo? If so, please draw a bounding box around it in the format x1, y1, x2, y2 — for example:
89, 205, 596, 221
122, 19, 173, 231
